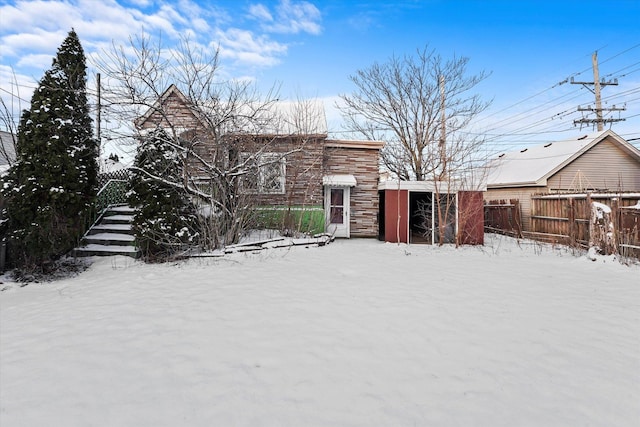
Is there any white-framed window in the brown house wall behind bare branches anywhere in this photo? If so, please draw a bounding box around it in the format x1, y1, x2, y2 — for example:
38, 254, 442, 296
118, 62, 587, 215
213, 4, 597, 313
241, 153, 286, 194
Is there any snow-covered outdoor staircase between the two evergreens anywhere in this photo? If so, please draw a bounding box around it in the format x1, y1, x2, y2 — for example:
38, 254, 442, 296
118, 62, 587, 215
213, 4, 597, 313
73, 205, 141, 258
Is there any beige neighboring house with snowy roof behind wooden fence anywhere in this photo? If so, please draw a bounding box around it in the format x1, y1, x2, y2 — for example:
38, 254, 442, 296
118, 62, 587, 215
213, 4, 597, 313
484, 130, 640, 231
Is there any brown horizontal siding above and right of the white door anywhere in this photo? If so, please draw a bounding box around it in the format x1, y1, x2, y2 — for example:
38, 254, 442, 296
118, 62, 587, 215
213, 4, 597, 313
325, 140, 381, 237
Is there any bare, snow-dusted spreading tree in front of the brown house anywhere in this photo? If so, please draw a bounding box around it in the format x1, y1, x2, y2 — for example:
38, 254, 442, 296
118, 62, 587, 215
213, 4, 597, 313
97, 35, 326, 254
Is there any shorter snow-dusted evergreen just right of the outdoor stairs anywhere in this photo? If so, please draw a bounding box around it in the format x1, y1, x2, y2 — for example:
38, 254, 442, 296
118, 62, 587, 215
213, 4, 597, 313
129, 129, 199, 261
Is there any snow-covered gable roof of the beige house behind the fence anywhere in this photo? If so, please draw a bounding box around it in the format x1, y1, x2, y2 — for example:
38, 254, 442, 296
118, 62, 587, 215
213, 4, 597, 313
487, 130, 640, 187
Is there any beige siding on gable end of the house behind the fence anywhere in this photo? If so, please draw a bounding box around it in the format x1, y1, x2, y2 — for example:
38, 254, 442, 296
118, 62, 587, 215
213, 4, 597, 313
547, 138, 640, 192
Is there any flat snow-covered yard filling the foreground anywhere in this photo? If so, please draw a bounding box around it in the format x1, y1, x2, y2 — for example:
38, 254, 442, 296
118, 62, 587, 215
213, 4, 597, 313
0, 236, 640, 427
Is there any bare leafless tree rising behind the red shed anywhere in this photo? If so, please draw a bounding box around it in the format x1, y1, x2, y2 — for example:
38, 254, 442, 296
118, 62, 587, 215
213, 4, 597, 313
338, 47, 488, 181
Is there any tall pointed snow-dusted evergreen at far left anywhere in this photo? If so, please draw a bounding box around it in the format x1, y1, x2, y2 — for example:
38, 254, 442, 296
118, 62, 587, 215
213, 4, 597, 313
3, 30, 98, 267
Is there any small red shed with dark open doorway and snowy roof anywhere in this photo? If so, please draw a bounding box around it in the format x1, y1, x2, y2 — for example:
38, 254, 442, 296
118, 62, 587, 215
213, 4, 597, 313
378, 180, 484, 245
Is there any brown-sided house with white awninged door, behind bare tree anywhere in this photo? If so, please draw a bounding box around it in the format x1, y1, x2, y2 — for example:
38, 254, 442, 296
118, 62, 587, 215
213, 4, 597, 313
135, 85, 384, 238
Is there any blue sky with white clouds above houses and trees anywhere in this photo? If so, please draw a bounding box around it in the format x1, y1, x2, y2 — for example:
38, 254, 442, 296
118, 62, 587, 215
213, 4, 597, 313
0, 0, 640, 157
